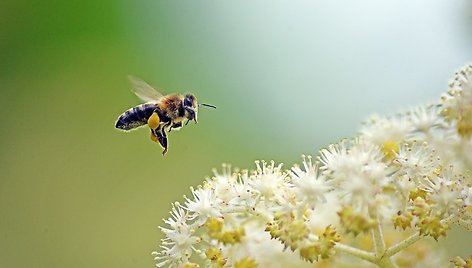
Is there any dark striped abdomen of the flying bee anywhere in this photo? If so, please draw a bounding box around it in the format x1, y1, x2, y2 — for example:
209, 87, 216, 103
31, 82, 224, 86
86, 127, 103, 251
115, 103, 157, 130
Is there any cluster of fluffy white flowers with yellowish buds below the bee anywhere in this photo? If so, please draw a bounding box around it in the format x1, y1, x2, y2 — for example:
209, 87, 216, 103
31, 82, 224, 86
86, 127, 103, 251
153, 63, 472, 267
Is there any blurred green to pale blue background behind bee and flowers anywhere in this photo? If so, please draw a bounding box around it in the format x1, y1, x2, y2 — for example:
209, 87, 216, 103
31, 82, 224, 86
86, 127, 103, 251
0, 0, 472, 268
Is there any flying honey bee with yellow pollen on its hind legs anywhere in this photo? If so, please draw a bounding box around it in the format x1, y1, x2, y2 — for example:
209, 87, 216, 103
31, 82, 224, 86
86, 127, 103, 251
115, 76, 216, 155
